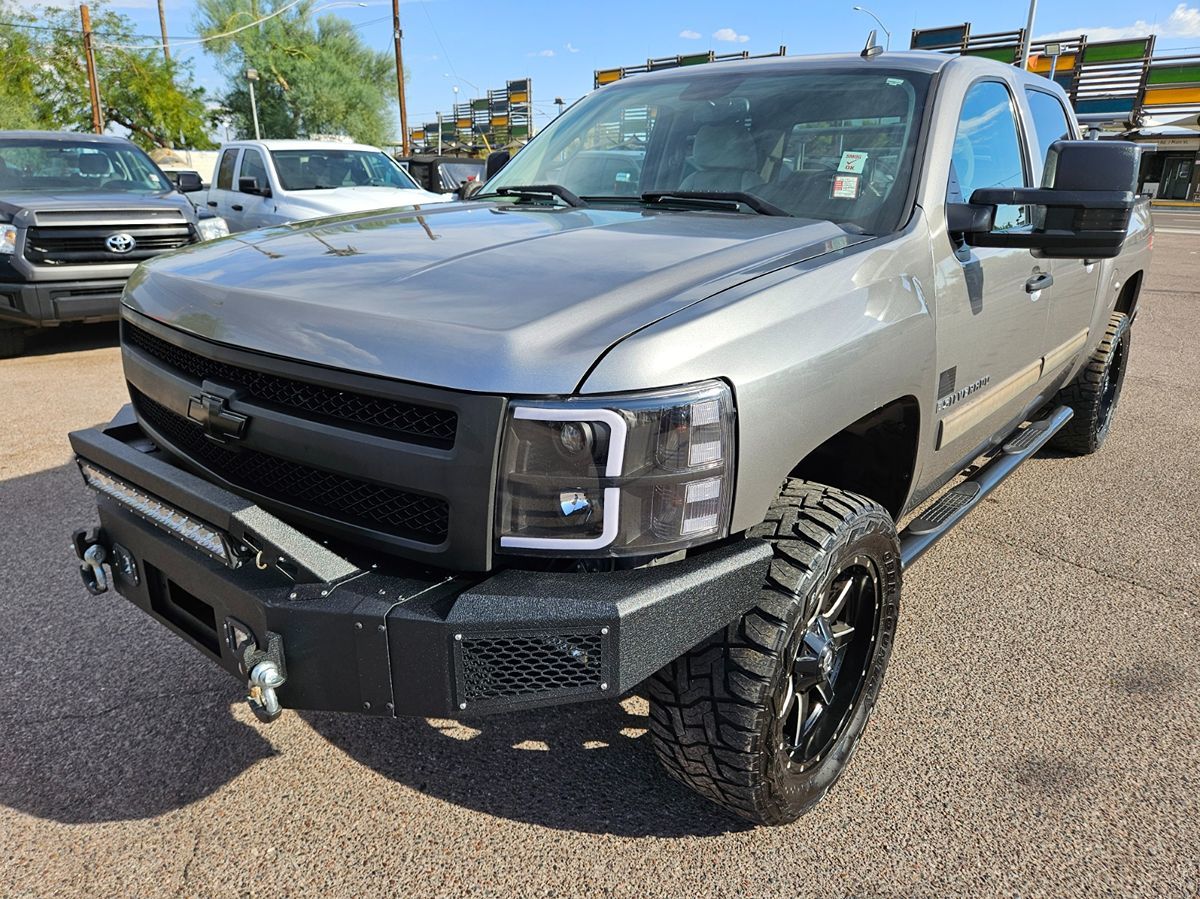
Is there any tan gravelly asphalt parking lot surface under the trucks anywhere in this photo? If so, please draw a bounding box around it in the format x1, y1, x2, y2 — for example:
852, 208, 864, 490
0, 210, 1200, 899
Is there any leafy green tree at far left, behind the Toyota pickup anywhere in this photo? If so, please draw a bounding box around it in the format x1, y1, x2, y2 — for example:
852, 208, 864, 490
0, 0, 212, 149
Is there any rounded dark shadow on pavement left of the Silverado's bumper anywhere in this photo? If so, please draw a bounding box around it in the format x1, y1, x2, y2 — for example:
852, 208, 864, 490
0, 465, 275, 820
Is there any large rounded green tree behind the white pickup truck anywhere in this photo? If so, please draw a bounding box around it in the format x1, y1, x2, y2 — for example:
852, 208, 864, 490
197, 0, 395, 144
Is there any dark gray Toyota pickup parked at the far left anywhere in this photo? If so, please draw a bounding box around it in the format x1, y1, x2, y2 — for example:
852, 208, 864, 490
0, 131, 228, 356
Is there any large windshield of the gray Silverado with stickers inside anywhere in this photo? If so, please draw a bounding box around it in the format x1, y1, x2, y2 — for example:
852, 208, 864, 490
481, 64, 929, 234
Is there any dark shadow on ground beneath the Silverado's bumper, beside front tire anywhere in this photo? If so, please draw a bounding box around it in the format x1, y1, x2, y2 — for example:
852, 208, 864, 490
302, 696, 751, 837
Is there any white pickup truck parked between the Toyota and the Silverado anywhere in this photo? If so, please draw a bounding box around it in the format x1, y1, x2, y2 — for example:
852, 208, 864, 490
208, 140, 454, 232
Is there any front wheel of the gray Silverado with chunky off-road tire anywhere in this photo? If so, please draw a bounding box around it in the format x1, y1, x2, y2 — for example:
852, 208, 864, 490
649, 480, 900, 825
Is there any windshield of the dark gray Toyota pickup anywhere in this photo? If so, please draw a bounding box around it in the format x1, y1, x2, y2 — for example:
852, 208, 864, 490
0, 138, 174, 193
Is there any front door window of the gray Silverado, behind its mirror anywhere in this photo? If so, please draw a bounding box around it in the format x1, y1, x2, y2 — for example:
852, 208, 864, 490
946, 82, 1030, 230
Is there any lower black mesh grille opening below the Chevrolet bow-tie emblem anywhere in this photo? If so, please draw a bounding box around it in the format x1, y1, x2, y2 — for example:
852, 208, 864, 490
131, 390, 450, 545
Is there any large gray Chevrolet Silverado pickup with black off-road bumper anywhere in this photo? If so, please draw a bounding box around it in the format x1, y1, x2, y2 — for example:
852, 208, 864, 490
71, 48, 1151, 823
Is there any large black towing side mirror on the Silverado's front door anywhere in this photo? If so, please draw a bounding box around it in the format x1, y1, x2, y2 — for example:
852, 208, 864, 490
947, 140, 1141, 259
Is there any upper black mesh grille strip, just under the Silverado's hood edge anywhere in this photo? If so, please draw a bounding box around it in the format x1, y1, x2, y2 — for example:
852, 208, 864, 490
122, 322, 458, 449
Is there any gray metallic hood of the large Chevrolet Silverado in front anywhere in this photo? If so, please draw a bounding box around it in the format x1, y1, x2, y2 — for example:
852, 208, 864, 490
125, 203, 869, 394
